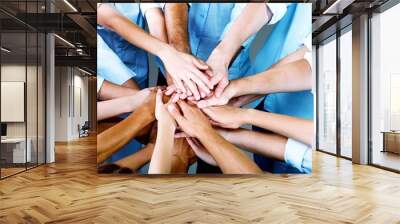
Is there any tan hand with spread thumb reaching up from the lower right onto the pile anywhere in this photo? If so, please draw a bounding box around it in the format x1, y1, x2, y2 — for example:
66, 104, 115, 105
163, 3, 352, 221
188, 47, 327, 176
168, 101, 214, 138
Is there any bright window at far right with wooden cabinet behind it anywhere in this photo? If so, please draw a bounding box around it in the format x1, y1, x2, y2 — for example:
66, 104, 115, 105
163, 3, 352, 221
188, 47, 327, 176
370, 4, 400, 170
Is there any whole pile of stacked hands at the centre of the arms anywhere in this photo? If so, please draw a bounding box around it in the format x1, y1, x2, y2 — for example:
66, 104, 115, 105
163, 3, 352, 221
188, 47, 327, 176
155, 61, 246, 166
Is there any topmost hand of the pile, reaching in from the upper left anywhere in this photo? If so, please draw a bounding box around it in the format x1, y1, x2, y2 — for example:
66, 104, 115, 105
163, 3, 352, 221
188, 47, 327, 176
160, 47, 213, 100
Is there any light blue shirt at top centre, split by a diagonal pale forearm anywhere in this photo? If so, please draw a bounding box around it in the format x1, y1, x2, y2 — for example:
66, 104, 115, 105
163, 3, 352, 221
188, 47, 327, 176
189, 3, 254, 80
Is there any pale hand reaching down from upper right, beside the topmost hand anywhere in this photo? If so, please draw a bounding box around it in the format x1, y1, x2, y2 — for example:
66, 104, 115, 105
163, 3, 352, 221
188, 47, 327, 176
207, 48, 229, 97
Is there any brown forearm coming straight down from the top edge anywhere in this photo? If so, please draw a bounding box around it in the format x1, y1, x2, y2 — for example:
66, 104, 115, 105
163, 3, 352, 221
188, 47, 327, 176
165, 3, 191, 53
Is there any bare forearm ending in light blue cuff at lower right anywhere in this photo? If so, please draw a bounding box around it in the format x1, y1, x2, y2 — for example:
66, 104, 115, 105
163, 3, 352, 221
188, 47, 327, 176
223, 129, 287, 161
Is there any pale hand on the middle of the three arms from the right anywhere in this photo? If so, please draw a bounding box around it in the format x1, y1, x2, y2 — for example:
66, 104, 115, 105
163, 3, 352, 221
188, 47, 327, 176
202, 106, 247, 129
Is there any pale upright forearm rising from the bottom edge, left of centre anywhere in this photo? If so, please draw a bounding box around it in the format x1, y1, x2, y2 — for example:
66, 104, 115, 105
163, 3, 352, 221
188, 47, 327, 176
149, 122, 175, 174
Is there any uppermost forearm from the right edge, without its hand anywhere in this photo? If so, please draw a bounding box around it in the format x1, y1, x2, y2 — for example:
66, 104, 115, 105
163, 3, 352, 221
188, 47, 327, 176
232, 59, 312, 96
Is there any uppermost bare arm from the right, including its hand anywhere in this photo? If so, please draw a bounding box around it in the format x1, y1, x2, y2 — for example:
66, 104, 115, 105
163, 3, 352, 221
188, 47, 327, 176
198, 48, 313, 108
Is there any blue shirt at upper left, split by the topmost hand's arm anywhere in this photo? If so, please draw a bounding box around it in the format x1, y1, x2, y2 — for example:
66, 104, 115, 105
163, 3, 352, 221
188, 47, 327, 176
97, 3, 148, 88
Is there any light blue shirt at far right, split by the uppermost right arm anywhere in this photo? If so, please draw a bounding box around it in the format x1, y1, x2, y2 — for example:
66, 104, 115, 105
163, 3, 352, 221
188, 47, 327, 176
250, 3, 314, 120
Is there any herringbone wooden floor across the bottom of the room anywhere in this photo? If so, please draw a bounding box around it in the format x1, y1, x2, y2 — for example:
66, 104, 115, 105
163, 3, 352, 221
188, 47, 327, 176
0, 138, 400, 223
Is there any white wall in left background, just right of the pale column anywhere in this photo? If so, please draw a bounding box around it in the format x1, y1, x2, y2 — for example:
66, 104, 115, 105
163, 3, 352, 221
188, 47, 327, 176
55, 67, 88, 141
